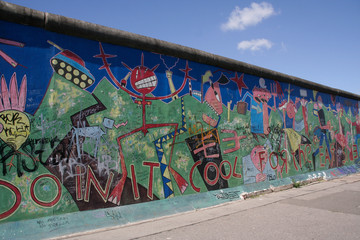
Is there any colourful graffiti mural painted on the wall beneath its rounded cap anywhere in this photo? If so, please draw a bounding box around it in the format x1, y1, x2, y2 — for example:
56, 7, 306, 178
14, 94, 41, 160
0, 21, 360, 224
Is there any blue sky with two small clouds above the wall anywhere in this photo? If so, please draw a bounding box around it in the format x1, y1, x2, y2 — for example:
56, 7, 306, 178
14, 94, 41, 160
3, 0, 360, 95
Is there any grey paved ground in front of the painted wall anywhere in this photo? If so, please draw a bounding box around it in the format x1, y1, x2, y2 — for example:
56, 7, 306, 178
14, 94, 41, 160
50, 174, 360, 240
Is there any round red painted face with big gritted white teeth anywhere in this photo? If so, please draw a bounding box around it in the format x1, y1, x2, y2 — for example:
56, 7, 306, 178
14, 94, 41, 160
130, 66, 158, 95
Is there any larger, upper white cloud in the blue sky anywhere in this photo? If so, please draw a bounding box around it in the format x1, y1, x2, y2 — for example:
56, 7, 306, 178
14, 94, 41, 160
221, 2, 276, 31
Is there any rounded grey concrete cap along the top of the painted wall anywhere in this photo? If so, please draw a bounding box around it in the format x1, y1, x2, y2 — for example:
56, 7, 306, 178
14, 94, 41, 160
0, 0, 360, 100
